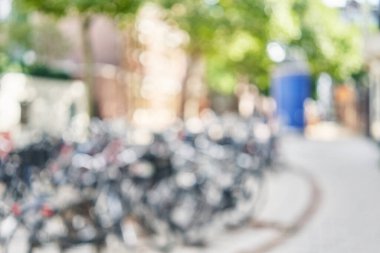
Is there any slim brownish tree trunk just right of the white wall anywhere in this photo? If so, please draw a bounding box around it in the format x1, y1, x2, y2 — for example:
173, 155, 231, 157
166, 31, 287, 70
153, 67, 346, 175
81, 14, 99, 117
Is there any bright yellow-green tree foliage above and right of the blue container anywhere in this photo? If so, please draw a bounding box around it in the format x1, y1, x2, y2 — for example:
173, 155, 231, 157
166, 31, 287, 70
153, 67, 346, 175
270, 0, 362, 81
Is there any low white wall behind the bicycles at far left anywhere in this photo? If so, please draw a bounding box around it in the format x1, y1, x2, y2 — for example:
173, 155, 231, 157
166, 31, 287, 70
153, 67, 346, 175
0, 73, 89, 144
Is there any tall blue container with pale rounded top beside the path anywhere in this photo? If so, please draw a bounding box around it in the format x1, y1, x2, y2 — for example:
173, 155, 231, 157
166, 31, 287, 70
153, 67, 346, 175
271, 63, 311, 131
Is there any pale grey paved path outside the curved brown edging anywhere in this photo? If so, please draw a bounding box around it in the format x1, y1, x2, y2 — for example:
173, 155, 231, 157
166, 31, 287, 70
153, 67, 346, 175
273, 133, 380, 253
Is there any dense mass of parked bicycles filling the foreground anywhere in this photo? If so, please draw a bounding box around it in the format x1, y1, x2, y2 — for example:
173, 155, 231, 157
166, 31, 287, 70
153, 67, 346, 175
0, 115, 275, 252
